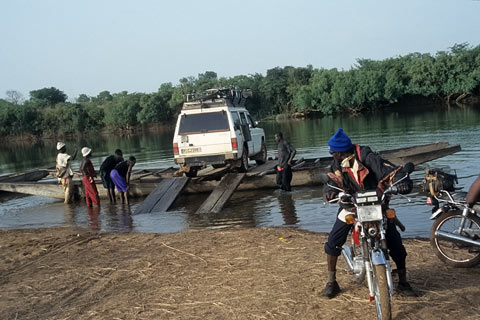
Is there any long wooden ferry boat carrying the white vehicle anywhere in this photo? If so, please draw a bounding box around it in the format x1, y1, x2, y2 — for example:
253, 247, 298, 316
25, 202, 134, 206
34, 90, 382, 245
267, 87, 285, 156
0, 142, 461, 199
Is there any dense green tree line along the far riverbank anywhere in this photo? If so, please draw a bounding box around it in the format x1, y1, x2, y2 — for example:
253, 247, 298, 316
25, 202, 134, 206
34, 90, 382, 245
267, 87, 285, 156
0, 44, 480, 135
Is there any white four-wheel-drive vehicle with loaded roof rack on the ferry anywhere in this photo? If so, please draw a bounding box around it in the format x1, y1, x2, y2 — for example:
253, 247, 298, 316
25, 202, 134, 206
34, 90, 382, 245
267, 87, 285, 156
173, 89, 267, 177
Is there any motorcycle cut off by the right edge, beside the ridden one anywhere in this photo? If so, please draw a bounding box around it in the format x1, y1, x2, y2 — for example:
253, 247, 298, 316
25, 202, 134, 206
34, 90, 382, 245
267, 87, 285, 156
427, 189, 480, 268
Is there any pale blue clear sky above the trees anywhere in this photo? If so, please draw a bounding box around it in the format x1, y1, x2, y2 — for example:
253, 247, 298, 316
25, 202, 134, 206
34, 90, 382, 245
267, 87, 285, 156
0, 0, 480, 101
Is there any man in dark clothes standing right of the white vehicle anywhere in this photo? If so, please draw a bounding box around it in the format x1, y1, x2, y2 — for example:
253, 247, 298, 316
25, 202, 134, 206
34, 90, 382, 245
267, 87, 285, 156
275, 132, 297, 191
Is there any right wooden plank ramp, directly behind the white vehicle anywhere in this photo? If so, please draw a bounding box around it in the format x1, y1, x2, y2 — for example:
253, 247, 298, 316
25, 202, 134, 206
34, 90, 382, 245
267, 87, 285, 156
195, 173, 245, 214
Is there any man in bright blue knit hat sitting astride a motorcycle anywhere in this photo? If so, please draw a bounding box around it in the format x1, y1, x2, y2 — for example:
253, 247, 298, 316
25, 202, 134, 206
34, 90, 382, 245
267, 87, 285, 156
322, 128, 416, 299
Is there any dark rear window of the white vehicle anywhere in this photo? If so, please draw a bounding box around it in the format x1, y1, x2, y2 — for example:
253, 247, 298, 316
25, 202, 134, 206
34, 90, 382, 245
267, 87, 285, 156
178, 111, 230, 134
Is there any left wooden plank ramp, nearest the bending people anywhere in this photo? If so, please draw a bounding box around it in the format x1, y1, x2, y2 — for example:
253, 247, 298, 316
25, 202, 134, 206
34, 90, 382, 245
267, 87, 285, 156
134, 177, 190, 214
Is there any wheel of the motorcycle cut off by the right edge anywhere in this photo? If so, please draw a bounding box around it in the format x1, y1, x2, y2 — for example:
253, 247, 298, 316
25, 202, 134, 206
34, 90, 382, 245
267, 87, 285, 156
430, 210, 480, 268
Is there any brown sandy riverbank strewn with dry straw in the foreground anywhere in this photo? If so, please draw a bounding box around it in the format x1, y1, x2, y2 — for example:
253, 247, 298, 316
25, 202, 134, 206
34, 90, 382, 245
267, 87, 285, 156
0, 228, 480, 319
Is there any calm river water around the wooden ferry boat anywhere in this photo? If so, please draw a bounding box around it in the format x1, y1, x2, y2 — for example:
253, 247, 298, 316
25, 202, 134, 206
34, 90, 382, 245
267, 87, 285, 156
0, 106, 480, 237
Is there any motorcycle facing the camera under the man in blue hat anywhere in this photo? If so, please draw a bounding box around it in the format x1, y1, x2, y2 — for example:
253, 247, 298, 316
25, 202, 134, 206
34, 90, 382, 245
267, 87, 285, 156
325, 163, 414, 319
